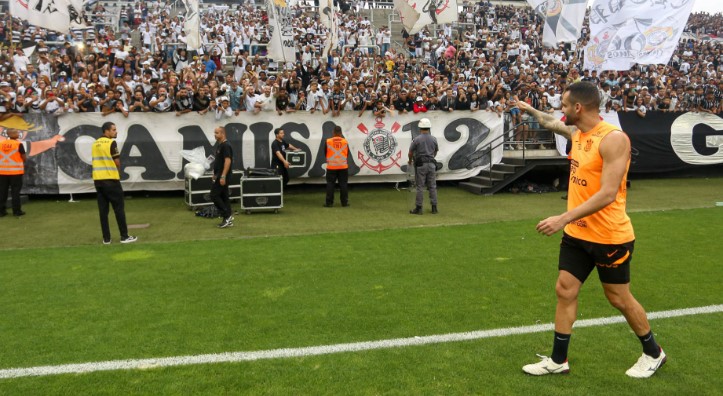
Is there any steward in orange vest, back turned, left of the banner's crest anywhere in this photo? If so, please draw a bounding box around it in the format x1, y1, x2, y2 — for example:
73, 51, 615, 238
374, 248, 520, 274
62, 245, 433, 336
324, 125, 349, 208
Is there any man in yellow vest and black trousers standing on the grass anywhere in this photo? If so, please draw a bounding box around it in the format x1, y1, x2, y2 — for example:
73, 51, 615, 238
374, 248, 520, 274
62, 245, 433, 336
92, 122, 138, 245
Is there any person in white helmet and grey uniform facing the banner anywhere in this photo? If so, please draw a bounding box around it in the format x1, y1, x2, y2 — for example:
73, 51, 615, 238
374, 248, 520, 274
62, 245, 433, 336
409, 118, 439, 215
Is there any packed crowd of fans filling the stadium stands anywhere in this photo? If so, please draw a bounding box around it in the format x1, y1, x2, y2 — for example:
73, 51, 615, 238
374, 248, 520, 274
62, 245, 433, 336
0, 1, 723, 133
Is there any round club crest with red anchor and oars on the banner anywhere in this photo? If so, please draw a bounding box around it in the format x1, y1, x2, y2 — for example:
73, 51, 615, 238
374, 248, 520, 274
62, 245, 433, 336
357, 118, 402, 174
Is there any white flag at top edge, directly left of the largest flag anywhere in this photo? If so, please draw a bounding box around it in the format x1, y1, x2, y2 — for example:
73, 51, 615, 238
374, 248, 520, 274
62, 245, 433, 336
542, 0, 587, 47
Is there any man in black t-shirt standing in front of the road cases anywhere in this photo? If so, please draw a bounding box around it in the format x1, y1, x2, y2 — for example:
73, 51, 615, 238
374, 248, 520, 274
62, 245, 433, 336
211, 127, 233, 228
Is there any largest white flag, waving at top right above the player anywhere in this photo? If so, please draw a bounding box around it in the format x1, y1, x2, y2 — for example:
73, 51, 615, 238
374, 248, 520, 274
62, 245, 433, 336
584, 0, 694, 70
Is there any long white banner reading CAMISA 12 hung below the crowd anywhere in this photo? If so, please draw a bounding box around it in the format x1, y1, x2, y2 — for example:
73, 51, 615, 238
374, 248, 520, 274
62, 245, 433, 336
49, 111, 503, 193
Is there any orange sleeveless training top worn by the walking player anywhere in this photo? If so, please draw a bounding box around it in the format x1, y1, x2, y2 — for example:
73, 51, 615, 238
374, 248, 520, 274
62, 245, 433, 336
565, 121, 635, 245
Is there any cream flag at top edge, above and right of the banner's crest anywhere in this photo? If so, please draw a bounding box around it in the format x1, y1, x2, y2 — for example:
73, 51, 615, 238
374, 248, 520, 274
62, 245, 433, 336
394, 0, 459, 34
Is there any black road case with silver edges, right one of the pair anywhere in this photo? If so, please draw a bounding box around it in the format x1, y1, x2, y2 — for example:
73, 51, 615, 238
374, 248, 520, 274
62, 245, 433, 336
241, 176, 284, 214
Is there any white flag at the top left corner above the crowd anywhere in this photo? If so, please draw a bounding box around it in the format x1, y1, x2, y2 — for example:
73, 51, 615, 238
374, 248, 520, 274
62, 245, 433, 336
10, 0, 79, 33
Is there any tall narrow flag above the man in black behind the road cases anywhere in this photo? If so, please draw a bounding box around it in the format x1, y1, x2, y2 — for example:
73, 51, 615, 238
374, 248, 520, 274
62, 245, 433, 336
267, 0, 296, 63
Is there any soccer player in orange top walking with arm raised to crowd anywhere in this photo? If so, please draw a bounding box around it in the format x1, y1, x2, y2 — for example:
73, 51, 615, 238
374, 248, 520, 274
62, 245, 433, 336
518, 82, 666, 378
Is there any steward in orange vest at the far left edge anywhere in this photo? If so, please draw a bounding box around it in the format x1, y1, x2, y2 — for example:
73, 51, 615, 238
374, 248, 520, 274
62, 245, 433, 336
0, 129, 28, 217
